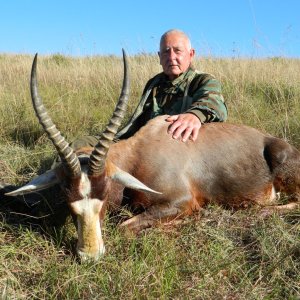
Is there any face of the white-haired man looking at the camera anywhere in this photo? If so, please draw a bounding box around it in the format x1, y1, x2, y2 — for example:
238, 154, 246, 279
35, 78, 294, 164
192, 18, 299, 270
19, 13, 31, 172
158, 32, 195, 80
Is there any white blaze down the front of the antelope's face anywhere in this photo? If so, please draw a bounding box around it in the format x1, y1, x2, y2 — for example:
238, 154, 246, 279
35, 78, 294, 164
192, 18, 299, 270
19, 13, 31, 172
70, 173, 105, 260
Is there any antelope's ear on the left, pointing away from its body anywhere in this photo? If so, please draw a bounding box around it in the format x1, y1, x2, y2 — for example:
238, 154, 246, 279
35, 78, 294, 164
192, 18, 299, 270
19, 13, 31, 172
5, 170, 59, 196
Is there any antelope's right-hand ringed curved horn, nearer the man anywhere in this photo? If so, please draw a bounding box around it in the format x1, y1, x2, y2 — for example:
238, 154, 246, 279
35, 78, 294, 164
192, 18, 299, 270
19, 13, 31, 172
88, 49, 129, 175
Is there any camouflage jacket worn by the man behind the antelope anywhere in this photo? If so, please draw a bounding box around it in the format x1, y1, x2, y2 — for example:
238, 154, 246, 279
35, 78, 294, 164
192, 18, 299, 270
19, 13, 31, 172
116, 68, 227, 139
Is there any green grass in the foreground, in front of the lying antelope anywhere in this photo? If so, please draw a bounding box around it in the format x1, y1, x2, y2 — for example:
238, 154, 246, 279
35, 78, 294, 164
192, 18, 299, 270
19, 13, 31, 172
0, 207, 300, 299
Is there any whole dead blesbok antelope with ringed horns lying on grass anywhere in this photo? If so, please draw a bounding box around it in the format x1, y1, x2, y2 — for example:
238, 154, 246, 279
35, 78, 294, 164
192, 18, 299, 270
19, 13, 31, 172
5, 49, 300, 259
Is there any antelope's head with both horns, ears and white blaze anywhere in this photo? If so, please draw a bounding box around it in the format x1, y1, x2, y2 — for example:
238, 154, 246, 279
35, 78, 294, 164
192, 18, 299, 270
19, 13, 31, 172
8, 50, 159, 260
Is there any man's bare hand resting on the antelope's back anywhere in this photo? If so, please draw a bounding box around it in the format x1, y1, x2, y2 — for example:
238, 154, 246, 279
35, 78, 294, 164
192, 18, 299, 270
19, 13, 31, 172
166, 113, 201, 142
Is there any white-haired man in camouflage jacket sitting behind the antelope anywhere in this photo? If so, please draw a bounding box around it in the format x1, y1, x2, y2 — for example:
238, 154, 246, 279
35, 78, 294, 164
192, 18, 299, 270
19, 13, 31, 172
71, 29, 227, 149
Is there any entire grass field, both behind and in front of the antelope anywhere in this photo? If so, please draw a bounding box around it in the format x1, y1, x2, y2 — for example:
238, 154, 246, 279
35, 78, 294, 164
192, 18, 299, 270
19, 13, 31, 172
0, 54, 300, 300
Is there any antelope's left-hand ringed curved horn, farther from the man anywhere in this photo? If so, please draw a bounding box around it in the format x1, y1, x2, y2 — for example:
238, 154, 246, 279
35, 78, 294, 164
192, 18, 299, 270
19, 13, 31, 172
30, 54, 81, 177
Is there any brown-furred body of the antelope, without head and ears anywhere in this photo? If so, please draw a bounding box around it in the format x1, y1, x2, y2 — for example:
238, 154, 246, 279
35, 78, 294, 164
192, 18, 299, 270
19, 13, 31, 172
93, 116, 300, 231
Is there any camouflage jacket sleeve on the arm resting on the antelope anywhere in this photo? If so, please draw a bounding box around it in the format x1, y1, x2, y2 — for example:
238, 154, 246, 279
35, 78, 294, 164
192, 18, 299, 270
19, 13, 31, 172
186, 74, 227, 123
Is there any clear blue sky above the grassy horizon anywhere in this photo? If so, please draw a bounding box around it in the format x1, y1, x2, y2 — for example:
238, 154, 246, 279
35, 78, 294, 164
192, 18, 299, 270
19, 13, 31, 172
0, 0, 300, 58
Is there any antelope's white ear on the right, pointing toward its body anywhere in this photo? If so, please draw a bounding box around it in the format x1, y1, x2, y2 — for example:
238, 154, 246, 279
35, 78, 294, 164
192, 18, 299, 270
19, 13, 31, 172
108, 164, 162, 194
